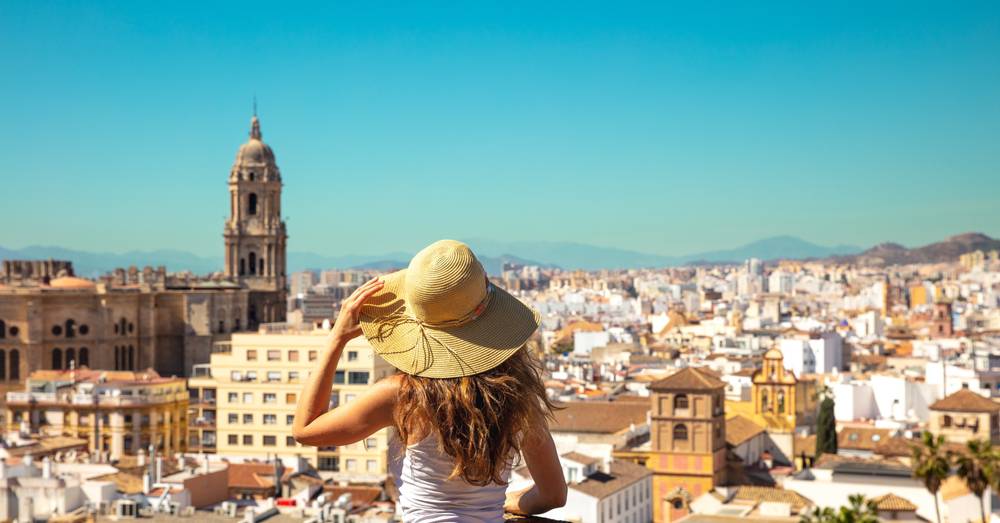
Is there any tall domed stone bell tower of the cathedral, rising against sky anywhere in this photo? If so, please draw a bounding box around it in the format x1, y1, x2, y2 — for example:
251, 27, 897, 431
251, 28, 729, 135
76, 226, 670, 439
223, 111, 288, 328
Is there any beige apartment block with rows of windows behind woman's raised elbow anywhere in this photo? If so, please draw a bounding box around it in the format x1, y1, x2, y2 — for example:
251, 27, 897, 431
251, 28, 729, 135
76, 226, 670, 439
188, 324, 394, 481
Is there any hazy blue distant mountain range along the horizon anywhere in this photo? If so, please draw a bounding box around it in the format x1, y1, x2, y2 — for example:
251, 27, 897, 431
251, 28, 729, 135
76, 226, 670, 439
0, 233, 1000, 277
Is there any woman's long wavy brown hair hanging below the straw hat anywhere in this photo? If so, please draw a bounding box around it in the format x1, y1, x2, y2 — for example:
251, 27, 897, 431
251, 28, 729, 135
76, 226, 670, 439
393, 347, 555, 486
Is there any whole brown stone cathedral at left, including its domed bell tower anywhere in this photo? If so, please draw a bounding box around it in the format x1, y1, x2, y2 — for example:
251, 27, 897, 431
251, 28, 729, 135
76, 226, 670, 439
0, 116, 288, 396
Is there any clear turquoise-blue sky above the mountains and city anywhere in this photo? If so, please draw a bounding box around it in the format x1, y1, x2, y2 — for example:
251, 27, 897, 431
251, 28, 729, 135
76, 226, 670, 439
0, 1, 1000, 256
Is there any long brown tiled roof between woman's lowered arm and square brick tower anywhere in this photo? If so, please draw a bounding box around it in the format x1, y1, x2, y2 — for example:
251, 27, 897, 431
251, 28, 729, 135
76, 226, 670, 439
549, 401, 650, 434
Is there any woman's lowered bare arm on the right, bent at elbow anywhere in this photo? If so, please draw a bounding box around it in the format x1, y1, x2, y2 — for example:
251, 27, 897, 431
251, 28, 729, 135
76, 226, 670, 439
504, 428, 566, 515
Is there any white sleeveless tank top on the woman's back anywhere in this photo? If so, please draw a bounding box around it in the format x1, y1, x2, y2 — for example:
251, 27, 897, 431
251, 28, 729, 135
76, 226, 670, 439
389, 436, 510, 523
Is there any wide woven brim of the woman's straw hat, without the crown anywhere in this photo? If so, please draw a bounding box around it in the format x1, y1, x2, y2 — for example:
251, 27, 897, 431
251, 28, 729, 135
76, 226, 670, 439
359, 269, 539, 378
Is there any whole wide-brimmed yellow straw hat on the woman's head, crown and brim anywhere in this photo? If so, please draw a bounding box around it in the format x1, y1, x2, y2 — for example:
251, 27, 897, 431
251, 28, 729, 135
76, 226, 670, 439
359, 240, 538, 378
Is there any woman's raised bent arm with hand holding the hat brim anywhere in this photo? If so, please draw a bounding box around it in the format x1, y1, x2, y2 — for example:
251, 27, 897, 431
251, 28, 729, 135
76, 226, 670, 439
292, 279, 396, 446
